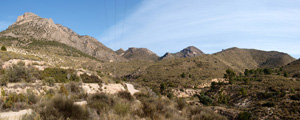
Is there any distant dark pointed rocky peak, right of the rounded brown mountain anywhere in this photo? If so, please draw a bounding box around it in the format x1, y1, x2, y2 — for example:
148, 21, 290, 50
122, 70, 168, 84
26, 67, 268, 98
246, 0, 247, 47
160, 46, 204, 60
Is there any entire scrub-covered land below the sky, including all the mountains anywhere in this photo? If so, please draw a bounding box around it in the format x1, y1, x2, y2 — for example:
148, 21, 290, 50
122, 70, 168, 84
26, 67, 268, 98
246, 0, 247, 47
0, 13, 300, 120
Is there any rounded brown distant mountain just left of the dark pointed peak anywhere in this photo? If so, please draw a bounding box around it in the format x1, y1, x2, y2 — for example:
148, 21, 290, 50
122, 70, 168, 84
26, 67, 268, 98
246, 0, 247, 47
122, 47, 159, 61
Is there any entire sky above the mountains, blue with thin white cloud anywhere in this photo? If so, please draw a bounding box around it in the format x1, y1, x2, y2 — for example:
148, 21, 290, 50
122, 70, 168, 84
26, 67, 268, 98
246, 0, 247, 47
0, 0, 300, 58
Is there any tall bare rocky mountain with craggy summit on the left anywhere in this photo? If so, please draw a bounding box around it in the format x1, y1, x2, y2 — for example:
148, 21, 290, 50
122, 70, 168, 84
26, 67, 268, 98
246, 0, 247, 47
0, 12, 126, 61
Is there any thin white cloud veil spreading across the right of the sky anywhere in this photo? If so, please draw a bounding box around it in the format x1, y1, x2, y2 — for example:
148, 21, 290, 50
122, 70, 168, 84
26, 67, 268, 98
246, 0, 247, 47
99, 0, 300, 55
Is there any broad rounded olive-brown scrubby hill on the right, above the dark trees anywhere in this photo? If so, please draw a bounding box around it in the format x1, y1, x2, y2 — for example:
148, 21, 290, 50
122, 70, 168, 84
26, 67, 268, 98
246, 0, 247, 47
126, 48, 295, 86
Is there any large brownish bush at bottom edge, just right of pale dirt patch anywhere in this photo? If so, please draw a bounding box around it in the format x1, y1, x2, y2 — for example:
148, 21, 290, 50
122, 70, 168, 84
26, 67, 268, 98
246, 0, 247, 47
39, 96, 89, 120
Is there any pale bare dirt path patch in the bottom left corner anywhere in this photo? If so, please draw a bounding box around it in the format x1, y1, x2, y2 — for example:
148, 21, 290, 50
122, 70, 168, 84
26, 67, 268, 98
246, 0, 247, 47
0, 109, 32, 120
